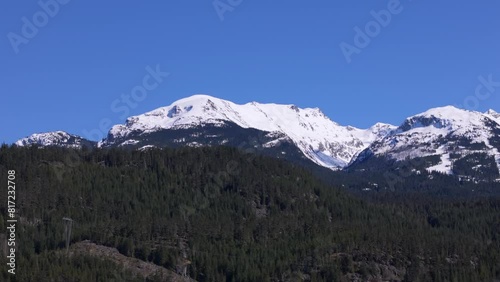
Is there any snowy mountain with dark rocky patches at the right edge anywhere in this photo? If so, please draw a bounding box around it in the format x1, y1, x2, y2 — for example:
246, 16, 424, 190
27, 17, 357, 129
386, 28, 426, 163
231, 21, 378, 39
355, 106, 500, 178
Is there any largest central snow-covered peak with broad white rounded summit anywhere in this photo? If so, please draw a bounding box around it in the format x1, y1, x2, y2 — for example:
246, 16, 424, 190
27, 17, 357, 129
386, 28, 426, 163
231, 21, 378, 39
99, 95, 396, 169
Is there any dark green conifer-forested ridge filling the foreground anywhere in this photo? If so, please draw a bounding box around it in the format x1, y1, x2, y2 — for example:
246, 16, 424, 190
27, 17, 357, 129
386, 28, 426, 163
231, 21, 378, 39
0, 145, 500, 281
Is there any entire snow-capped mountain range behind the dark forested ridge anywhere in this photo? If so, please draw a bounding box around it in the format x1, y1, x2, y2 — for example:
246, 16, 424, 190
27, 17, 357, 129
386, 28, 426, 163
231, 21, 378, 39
15, 95, 500, 180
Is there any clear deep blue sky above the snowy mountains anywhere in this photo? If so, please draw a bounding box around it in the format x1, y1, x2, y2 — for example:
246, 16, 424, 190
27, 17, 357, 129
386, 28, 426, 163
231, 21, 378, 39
0, 0, 500, 143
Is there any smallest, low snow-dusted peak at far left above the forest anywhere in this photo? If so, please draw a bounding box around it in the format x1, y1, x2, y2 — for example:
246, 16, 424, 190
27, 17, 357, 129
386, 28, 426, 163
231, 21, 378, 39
15, 131, 95, 148
